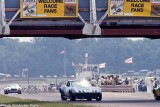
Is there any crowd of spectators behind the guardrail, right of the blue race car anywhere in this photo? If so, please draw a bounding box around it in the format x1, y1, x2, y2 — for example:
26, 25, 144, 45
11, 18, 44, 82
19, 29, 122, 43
91, 75, 160, 93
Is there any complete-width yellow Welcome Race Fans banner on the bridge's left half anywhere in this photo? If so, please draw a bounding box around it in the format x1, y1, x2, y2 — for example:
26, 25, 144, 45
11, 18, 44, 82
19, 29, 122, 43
20, 0, 78, 18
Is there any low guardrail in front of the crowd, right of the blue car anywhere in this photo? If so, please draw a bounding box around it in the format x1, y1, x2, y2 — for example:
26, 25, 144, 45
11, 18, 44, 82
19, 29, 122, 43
100, 85, 135, 93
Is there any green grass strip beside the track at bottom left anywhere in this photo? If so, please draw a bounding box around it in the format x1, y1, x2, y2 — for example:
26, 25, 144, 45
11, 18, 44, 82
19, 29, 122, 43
0, 95, 93, 107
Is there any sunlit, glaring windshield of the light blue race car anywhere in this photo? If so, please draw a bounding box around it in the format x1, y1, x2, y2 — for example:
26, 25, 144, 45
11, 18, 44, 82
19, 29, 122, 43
72, 80, 91, 87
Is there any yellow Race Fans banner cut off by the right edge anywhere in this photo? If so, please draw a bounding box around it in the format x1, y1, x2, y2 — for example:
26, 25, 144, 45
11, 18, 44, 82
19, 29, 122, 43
108, 0, 160, 17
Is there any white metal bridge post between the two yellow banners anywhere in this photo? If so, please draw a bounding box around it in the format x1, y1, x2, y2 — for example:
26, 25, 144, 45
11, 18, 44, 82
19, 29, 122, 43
83, 0, 101, 35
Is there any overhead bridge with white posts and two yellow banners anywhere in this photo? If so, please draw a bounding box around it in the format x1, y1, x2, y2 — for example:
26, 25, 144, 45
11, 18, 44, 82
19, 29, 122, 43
0, 0, 160, 39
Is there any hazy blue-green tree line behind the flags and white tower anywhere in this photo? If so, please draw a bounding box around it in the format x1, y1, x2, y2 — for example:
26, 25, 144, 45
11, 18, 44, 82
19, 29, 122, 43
0, 37, 160, 76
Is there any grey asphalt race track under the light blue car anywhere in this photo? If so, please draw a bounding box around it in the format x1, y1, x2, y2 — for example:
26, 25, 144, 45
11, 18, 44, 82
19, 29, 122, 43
0, 90, 160, 107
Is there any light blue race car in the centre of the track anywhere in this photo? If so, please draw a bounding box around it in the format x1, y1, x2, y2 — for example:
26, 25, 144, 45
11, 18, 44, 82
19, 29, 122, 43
59, 80, 102, 101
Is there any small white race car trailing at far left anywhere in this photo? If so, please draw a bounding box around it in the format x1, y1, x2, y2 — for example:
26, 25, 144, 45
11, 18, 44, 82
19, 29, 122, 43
4, 84, 22, 94
